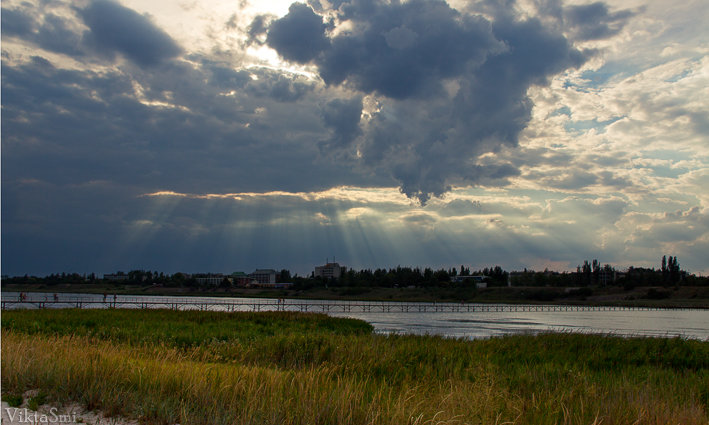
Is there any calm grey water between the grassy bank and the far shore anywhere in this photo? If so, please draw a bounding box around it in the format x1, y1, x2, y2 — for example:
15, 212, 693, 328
2, 292, 709, 341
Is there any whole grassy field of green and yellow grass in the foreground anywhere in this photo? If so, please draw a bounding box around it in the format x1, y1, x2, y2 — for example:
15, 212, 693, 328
2, 310, 709, 424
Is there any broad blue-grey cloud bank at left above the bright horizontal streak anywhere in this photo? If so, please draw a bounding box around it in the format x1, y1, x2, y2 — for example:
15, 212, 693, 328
2, 43, 393, 199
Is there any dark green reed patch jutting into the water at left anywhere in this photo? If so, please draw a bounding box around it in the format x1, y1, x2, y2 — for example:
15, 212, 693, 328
2, 309, 373, 347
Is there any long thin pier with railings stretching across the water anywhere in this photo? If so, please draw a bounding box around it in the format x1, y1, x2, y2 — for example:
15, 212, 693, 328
2, 294, 676, 313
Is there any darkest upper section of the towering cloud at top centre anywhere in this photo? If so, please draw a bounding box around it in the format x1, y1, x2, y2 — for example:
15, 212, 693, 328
267, 0, 503, 99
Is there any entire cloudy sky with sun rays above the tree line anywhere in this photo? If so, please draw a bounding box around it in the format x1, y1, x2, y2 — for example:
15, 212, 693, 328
1, 0, 709, 275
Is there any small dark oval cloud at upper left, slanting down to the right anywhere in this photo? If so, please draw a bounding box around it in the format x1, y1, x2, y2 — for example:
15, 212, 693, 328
80, 0, 182, 66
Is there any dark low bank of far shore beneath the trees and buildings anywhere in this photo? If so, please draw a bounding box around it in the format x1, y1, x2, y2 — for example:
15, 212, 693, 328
2, 283, 709, 309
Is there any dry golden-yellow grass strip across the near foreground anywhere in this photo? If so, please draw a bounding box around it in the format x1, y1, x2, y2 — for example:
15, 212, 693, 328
2, 332, 513, 424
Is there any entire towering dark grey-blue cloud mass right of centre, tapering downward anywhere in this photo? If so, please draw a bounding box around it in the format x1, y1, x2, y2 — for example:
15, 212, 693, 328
260, 0, 596, 202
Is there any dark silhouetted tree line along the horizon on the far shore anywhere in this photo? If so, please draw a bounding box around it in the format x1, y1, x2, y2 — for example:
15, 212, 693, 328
3, 255, 709, 289
